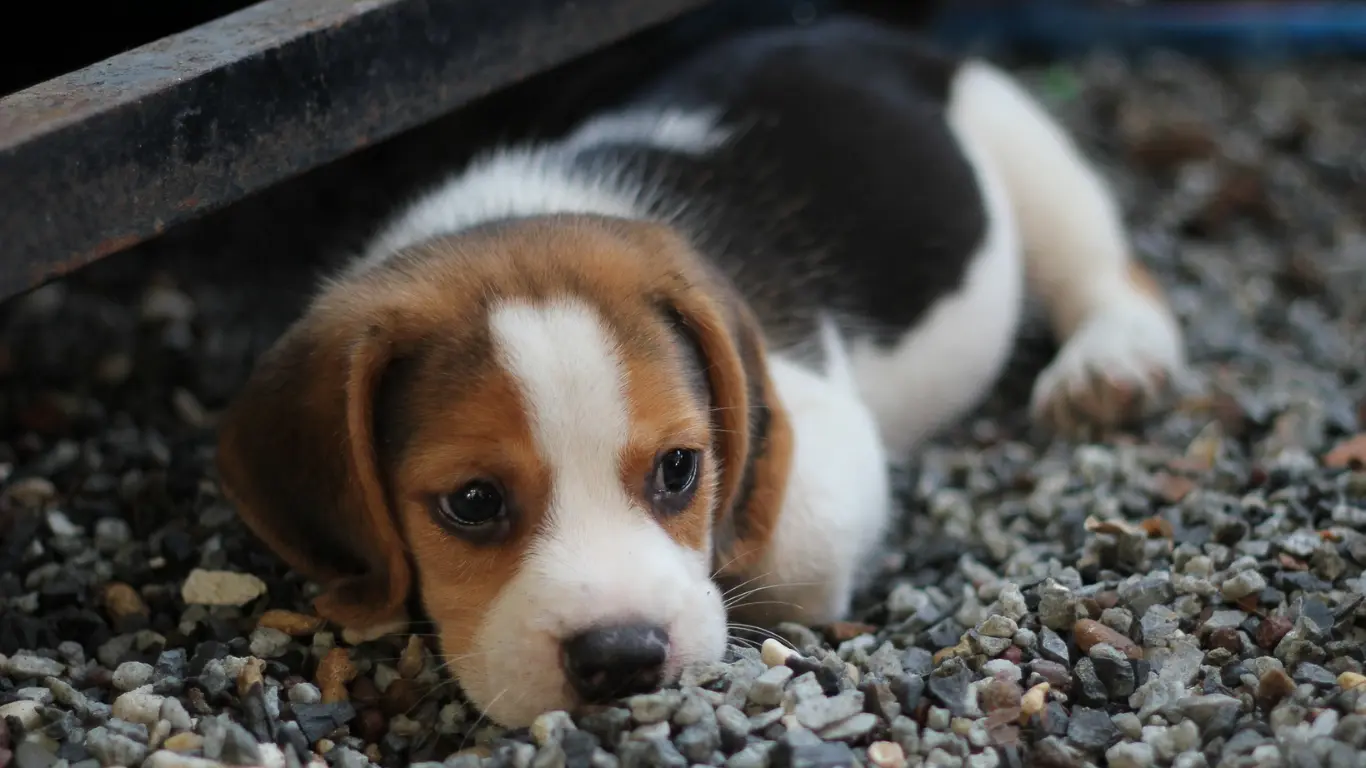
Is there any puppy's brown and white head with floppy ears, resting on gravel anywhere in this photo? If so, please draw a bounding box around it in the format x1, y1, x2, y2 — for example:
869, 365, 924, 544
219, 217, 791, 726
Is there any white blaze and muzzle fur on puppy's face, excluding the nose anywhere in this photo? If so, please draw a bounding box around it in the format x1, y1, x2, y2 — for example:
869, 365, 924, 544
458, 299, 727, 727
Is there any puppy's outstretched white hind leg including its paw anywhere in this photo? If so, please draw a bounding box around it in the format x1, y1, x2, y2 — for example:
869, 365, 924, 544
949, 61, 1184, 433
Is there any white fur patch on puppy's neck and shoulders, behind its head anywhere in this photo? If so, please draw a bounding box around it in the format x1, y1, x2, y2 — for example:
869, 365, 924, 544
351, 108, 731, 275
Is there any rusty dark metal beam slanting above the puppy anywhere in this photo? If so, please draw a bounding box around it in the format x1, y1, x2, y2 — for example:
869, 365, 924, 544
0, 0, 709, 297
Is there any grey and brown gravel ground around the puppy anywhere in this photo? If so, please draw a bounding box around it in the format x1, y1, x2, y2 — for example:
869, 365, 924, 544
0, 46, 1366, 768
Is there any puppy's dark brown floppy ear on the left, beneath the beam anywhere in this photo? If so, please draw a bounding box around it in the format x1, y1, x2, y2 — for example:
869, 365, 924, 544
217, 307, 411, 633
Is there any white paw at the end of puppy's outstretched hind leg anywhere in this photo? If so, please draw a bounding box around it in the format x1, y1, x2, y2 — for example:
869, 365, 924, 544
1030, 295, 1186, 437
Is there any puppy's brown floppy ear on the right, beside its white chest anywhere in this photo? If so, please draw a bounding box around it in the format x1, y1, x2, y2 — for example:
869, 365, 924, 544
658, 286, 792, 577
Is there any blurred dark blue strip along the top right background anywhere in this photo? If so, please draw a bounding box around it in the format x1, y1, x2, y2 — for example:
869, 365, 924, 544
934, 0, 1366, 57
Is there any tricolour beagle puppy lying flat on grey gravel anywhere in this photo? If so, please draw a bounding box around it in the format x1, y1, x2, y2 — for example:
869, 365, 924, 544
219, 19, 1183, 727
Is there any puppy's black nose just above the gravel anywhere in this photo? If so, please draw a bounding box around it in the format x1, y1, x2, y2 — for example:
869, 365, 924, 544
563, 625, 669, 702
